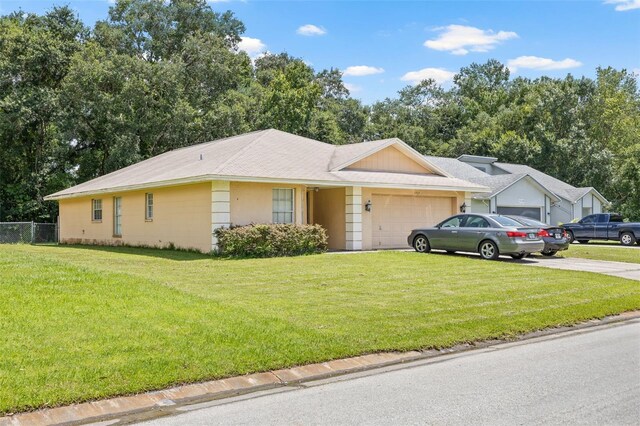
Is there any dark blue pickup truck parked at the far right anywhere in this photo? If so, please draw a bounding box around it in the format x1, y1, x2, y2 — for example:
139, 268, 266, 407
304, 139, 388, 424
562, 213, 640, 246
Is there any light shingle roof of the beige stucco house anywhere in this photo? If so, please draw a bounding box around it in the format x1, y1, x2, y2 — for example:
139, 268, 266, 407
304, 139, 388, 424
47, 129, 486, 199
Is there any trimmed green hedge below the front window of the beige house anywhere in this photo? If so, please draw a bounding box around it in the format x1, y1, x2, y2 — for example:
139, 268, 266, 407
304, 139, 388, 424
216, 224, 327, 257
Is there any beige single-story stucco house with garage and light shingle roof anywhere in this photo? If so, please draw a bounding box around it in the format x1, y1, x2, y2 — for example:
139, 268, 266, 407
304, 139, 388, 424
47, 130, 488, 252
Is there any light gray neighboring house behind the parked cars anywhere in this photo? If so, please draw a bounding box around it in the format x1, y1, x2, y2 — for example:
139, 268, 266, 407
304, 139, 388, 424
426, 155, 609, 225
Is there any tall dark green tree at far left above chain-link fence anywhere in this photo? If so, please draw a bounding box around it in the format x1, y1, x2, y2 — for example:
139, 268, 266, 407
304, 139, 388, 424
0, 7, 88, 220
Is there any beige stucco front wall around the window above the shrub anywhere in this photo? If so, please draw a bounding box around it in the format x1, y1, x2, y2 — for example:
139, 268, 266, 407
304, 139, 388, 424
230, 182, 306, 225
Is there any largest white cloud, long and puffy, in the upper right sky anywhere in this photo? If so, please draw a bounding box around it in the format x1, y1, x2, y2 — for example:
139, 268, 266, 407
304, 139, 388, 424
424, 25, 518, 55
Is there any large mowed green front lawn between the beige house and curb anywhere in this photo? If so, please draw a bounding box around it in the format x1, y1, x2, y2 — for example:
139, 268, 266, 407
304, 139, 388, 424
0, 245, 640, 413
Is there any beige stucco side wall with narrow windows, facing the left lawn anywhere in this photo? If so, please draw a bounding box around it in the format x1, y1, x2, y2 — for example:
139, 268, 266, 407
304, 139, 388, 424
60, 182, 211, 252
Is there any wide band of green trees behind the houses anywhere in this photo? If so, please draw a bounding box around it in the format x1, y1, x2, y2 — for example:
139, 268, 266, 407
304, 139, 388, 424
0, 0, 640, 221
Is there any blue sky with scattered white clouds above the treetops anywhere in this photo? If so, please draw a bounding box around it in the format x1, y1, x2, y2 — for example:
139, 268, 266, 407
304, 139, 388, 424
5, 0, 640, 103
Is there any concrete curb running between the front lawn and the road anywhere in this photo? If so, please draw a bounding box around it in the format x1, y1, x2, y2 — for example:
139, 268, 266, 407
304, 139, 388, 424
0, 311, 640, 426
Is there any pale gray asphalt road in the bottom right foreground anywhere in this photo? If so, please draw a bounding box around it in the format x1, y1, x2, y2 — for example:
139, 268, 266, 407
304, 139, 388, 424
142, 320, 640, 425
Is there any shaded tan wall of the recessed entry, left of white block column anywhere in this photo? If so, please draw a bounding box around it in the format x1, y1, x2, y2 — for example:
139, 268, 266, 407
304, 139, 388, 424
313, 188, 346, 250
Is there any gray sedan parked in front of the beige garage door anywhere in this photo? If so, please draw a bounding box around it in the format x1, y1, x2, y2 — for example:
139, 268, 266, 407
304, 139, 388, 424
407, 213, 544, 260
